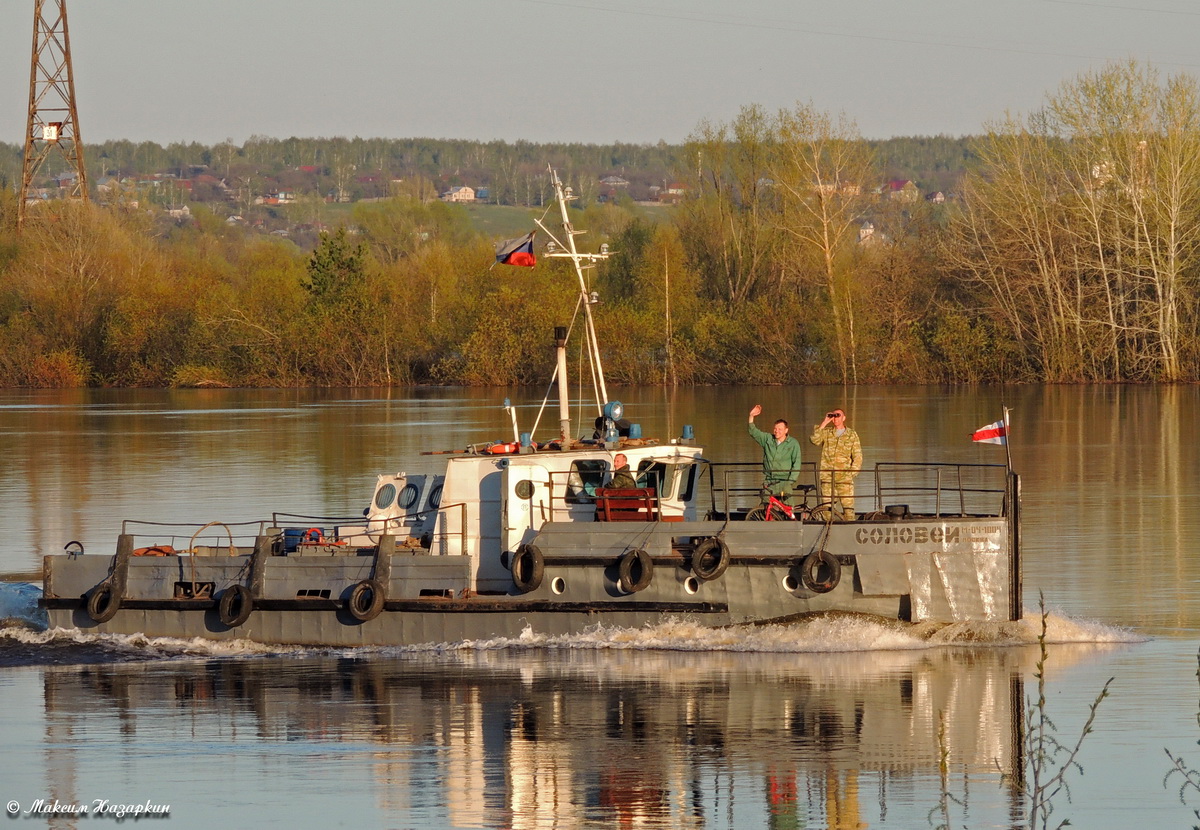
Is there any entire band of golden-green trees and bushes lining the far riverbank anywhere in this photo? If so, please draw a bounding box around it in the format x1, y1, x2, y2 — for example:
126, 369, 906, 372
0, 64, 1200, 386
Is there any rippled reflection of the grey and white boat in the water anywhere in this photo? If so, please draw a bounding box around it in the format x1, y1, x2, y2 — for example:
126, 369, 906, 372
44, 648, 1030, 828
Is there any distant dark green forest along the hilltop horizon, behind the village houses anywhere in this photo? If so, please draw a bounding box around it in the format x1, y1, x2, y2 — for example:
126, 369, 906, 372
0, 136, 971, 206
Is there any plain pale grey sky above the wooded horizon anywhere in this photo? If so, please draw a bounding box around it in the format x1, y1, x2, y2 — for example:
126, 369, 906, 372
0, 0, 1200, 145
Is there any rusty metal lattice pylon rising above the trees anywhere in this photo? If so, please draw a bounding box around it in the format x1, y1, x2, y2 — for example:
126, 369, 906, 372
17, 0, 88, 227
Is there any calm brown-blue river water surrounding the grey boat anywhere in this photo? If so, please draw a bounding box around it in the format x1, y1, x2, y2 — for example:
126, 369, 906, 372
0, 386, 1200, 829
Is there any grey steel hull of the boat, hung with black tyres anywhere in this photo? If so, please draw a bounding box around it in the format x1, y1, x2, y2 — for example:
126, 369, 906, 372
42, 517, 1020, 646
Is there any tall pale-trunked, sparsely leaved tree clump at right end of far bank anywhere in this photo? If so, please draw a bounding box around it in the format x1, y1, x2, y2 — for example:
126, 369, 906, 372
946, 61, 1200, 380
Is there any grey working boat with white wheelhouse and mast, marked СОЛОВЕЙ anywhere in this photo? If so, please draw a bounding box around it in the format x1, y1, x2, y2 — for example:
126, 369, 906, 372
40, 170, 1021, 646
